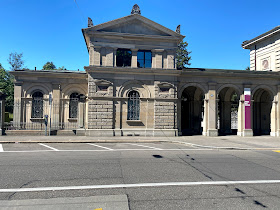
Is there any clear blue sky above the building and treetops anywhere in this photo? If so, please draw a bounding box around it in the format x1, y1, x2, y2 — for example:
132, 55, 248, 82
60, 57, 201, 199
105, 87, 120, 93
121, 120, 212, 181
0, 0, 280, 70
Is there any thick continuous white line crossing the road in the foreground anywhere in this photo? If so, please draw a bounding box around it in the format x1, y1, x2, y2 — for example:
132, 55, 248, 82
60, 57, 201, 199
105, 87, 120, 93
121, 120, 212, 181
0, 180, 280, 193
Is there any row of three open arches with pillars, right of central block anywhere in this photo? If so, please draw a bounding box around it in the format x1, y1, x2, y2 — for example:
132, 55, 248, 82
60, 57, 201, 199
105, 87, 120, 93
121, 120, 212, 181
178, 85, 274, 136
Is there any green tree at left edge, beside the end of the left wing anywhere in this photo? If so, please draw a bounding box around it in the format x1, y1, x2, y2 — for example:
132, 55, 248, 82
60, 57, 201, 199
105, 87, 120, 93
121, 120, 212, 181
0, 63, 14, 113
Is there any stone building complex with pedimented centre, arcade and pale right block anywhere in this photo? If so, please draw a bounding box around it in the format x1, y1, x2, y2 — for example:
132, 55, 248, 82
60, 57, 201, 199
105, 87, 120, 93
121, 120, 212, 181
10, 5, 280, 136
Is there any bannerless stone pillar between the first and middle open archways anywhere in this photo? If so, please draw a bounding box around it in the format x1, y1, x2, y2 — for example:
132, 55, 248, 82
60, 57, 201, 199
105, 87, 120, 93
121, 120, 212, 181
207, 83, 218, 136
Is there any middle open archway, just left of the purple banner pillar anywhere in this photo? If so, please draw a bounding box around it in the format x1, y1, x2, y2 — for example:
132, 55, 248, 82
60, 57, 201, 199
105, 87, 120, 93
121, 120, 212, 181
217, 87, 240, 135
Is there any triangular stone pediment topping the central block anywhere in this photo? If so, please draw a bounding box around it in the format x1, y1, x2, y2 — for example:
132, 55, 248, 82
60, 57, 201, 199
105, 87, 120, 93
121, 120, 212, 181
88, 14, 183, 38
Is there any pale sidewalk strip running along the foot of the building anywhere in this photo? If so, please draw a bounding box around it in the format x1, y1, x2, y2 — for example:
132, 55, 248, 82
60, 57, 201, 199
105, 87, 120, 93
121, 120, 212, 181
0, 136, 280, 150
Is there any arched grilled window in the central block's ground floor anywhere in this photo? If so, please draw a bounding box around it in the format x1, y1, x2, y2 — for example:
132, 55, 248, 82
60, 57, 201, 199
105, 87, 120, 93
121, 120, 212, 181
127, 91, 140, 120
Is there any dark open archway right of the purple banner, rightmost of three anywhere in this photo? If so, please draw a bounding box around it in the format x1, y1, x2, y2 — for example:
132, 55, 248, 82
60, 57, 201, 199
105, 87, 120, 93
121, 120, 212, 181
253, 88, 273, 136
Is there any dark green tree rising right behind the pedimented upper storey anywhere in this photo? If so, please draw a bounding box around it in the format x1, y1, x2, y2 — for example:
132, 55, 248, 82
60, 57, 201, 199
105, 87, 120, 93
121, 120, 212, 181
176, 41, 191, 69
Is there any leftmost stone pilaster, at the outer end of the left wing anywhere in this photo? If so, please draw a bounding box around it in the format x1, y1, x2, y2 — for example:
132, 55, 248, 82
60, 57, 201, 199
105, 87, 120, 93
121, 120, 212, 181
13, 82, 22, 128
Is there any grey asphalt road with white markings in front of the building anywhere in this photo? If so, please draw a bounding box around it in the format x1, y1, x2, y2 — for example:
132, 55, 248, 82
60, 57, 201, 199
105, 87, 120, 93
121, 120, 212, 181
0, 143, 280, 210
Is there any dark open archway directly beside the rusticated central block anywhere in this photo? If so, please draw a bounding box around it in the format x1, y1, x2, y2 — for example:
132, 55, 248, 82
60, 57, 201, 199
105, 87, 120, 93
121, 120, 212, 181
181, 86, 204, 135
